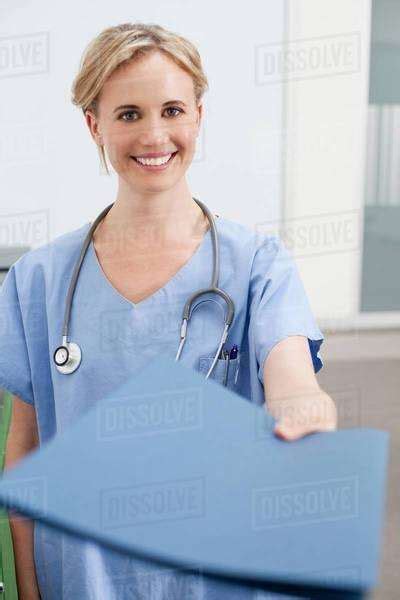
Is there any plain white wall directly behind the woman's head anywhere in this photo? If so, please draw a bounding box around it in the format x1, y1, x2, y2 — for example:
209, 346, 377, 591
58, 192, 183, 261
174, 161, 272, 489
0, 0, 284, 247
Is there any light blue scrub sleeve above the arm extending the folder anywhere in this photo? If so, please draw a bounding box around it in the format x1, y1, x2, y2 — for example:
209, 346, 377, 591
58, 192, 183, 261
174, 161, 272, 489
249, 236, 324, 385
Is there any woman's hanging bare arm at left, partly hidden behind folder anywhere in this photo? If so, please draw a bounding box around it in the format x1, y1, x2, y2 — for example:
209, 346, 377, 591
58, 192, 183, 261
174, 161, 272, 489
4, 396, 40, 600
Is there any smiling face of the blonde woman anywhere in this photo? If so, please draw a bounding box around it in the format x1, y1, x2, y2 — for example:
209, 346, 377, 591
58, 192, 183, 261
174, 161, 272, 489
86, 51, 202, 192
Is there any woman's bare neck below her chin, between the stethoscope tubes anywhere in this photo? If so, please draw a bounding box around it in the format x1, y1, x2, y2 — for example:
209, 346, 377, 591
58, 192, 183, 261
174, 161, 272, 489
93, 180, 209, 247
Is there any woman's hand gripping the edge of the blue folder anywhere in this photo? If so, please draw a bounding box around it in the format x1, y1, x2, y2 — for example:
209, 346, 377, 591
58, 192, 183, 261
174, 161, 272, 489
268, 388, 337, 441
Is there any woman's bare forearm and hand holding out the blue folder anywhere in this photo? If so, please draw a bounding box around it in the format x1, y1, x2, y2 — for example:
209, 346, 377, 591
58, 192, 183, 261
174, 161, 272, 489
264, 335, 337, 440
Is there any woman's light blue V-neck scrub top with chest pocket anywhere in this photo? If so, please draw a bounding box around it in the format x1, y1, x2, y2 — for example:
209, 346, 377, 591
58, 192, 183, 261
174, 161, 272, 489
0, 217, 324, 600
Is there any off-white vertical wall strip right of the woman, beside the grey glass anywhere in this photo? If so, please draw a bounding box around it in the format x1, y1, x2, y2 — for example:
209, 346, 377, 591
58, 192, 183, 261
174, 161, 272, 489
283, 0, 370, 328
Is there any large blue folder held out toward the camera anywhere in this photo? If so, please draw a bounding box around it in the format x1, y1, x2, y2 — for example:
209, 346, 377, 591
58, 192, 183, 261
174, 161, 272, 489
0, 358, 388, 598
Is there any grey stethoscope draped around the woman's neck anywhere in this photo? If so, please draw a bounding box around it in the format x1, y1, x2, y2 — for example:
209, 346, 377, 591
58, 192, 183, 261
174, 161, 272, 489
53, 197, 235, 379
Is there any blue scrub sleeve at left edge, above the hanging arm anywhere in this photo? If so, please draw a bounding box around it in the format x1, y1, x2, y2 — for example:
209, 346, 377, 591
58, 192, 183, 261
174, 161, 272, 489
0, 265, 34, 405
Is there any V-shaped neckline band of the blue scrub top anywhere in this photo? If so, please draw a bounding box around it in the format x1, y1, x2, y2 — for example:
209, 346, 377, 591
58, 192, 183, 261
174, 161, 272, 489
87, 224, 214, 309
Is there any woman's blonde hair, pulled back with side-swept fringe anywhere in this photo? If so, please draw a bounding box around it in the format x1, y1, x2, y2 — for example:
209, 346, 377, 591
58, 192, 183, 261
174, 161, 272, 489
71, 23, 208, 175
